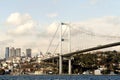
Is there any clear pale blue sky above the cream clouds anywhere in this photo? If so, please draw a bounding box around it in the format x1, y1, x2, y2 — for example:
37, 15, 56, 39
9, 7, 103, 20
0, 0, 120, 23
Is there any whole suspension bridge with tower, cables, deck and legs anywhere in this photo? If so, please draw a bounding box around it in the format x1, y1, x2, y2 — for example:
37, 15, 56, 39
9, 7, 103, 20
42, 23, 120, 74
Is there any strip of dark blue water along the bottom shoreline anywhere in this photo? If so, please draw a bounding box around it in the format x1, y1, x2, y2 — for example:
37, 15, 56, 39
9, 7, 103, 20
0, 75, 120, 80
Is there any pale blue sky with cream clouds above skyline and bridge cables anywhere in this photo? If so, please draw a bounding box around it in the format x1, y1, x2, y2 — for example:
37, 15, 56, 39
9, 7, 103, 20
0, 0, 120, 57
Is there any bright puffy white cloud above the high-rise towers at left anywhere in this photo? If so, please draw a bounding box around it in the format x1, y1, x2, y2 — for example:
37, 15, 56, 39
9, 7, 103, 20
6, 13, 37, 36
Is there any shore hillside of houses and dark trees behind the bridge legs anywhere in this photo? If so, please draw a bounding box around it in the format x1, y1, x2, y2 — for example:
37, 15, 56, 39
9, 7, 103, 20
0, 47, 120, 75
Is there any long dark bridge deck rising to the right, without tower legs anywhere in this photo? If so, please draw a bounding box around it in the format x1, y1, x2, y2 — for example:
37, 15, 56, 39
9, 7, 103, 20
43, 42, 120, 61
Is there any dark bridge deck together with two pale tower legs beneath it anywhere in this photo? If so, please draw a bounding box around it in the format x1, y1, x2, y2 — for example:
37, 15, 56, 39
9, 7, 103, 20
43, 42, 120, 75
